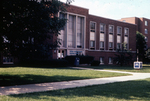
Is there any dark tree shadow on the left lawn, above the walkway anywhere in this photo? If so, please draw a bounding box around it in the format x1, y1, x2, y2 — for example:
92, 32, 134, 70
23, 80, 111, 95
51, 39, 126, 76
0, 74, 89, 86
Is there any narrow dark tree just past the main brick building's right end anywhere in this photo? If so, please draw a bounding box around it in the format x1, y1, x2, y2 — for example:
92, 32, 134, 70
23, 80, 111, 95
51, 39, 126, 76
136, 31, 146, 60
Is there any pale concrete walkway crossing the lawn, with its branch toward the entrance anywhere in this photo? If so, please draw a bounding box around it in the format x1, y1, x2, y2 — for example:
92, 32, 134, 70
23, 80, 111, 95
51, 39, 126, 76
0, 67, 150, 95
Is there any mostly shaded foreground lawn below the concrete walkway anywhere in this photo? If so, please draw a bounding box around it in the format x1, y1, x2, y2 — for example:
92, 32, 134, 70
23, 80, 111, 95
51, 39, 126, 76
10, 79, 150, 101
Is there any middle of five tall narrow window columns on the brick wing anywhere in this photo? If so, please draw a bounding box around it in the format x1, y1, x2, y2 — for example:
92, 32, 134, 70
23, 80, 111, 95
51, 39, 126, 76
108, 25, 114, 50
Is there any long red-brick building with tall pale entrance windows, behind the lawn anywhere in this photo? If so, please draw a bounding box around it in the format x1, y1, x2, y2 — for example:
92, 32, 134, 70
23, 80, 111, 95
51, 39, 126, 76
53, 5, 137, 65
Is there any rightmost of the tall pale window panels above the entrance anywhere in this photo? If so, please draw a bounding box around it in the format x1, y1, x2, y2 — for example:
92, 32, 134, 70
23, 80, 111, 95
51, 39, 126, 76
77, 17, 84, 48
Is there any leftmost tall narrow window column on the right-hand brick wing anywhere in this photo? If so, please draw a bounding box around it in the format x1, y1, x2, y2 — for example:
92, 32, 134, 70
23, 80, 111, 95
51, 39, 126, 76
90, 22, 96, 49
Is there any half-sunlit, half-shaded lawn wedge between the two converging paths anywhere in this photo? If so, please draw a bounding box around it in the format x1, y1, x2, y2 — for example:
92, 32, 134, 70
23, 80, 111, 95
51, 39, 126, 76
0, 67, 129, 86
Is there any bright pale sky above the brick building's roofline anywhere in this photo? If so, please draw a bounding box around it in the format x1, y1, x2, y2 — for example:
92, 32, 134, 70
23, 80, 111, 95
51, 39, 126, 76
60, 0, 150, 20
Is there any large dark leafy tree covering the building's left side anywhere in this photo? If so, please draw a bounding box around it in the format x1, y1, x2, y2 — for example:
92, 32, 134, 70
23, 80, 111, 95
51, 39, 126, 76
0, 0, 69, 59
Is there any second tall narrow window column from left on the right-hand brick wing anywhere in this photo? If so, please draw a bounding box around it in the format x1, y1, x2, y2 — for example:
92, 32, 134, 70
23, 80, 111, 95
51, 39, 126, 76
100, 23, 105, 50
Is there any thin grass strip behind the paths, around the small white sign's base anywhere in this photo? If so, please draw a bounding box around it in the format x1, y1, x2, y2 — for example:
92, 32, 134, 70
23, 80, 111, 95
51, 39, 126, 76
82, 64, 150, 73
